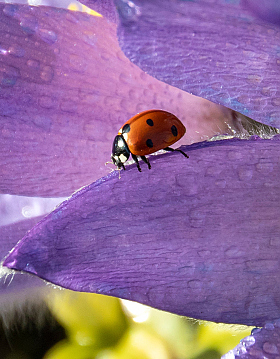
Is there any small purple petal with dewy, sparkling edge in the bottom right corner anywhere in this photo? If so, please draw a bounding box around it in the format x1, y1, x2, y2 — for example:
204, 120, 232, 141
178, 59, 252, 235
222, 320, 280, 359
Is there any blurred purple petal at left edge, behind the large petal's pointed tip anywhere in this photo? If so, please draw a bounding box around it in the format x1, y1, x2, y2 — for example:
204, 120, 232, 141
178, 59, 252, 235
0, 217, 44, 295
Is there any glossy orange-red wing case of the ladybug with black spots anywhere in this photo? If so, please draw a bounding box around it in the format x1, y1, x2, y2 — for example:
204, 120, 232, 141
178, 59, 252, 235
118, 110, 186, 156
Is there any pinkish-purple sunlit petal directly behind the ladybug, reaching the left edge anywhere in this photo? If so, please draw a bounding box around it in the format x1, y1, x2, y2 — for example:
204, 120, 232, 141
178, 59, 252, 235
0, 4, 233, 197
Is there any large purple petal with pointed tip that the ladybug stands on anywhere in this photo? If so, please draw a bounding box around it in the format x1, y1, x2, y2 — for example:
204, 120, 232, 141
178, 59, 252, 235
4, 136, 280, 325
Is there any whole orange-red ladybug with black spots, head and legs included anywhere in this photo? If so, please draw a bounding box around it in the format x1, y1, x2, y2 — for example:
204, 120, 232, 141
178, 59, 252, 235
111, 110, 189, 172
